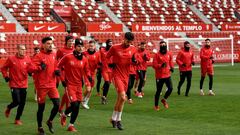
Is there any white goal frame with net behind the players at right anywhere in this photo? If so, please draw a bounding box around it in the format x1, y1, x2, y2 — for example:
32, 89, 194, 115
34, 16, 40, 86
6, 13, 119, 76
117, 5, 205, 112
161, 37, 238, 66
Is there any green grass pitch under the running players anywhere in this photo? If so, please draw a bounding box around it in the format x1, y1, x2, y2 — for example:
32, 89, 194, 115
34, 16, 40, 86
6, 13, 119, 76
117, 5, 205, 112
0, 64, 240, 135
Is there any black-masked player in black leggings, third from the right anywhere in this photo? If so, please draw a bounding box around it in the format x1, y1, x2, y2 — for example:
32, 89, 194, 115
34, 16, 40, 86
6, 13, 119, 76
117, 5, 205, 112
153, 41, 174, 111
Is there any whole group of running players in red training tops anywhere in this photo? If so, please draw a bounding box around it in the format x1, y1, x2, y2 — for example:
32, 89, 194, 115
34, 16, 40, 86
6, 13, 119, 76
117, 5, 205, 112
1, 32, 215, 135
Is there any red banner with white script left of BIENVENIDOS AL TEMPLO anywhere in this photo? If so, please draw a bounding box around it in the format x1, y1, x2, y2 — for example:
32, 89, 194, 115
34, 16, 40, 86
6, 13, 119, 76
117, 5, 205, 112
87, 23, 123, 32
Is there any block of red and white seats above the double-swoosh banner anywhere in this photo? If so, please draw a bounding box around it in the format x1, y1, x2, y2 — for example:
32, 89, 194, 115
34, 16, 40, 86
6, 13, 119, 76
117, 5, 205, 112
2, 0, 112, 29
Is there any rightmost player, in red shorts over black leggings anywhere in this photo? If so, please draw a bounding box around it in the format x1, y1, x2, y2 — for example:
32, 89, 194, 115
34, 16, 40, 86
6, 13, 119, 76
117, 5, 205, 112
200, 39, 215, 96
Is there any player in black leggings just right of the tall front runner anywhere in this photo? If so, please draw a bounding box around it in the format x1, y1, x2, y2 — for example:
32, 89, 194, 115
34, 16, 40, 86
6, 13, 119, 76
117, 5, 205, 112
136, 42, 150, 98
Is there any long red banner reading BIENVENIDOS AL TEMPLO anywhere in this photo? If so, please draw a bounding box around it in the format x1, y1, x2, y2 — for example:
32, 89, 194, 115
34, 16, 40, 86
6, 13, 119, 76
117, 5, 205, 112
132, 24, 213, 32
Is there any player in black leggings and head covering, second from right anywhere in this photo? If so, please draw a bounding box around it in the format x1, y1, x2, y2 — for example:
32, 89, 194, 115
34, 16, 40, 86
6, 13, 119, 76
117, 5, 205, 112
176, 41, 195, 97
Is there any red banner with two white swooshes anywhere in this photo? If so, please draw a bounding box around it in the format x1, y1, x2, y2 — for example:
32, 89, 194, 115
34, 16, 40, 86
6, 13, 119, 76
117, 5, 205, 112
28, 23, 66, 32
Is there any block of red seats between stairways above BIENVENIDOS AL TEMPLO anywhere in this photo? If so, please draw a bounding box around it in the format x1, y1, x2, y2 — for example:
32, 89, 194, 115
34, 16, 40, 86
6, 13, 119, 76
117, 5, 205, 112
105, 0, 202, 27
